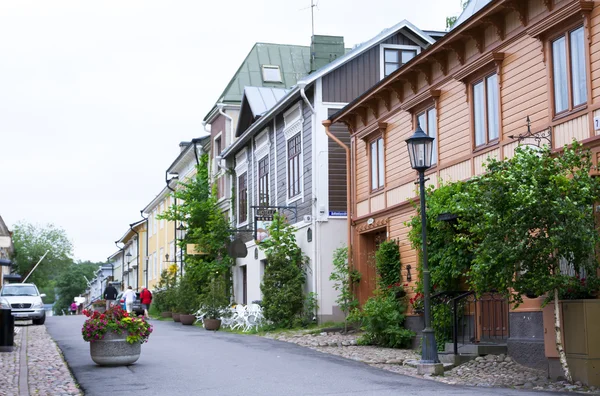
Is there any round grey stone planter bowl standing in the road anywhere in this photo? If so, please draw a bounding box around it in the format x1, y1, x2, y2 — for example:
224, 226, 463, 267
90, 331, 142, 366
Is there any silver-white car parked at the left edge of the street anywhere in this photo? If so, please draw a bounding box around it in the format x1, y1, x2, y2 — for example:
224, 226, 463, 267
0, 283, 46, 325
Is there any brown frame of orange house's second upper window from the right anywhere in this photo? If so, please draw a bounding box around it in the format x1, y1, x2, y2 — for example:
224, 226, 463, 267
468, 68, 502, 151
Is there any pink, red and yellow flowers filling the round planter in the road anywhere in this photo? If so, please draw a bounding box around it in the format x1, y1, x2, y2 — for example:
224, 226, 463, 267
81, 305, 152, 344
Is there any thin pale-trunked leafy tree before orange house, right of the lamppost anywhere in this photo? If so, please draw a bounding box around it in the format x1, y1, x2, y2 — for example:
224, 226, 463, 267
470, 142, 600, 382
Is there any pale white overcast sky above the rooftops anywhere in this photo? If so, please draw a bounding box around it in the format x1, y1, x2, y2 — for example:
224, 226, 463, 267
0, 0, 460, 261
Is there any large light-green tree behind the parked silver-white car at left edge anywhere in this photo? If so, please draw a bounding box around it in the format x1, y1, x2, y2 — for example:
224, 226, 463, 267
13, 222, 73, 287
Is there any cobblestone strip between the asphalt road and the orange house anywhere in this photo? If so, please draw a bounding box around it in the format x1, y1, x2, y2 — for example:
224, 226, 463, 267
265, 331, 600, 394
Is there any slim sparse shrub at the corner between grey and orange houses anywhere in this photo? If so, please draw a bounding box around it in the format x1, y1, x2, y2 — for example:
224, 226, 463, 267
329, 247, 360, 331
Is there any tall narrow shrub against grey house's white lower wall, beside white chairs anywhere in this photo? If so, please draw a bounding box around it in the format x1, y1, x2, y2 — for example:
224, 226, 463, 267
259, 213, 306, 328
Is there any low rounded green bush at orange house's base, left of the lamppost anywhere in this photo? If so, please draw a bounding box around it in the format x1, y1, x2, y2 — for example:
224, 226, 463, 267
349, 291, 414, 348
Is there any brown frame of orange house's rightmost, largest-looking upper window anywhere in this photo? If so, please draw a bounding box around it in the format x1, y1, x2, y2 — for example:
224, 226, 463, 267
545, 23, 591, 120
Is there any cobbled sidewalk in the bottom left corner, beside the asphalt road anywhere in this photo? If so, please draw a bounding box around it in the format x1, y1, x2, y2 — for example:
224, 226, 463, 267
0, 325, 82, 396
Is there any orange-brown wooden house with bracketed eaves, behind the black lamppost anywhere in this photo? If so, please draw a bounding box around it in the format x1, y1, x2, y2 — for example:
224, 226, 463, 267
324, 0, 600, 368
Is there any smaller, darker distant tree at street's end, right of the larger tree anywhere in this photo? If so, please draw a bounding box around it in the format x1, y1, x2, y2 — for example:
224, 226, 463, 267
55, 261, 101, 314
